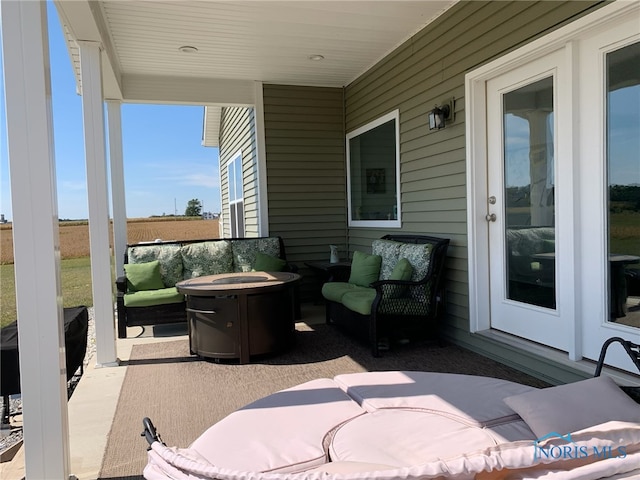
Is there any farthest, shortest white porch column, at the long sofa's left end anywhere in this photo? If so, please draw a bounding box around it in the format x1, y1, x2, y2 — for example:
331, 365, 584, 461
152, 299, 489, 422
107, 100, 127, 277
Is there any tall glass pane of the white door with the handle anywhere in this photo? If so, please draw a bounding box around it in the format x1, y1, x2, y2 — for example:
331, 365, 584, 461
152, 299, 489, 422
503, 77, 556, 308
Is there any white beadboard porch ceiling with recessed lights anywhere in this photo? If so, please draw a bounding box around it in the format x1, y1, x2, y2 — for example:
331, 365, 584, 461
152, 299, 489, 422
55, 0, 457, 104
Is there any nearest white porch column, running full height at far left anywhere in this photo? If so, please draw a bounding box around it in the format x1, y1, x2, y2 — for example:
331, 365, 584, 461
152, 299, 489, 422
0, 2, 69, 479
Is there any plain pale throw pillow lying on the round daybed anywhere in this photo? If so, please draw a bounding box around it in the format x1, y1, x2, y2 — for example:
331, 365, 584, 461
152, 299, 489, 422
504, 376, 640, 438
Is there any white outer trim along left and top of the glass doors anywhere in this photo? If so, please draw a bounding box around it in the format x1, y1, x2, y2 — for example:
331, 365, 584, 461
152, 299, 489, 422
465, 1, 639, 361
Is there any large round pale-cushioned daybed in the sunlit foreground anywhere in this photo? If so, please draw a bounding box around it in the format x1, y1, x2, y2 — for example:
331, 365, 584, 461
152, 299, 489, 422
144, 371, 640, 480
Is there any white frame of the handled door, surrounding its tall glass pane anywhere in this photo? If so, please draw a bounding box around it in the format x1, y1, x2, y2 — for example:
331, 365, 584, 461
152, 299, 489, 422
479, 51, 576, 351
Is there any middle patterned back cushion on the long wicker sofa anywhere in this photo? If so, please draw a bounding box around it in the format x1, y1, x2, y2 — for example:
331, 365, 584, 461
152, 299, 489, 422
181, 240, 233, 279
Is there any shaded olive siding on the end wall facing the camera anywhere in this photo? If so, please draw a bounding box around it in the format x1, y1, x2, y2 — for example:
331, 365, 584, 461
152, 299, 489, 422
263, 85, 347, 299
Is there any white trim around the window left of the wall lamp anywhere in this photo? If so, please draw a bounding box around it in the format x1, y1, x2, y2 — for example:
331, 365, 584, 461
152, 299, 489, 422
346, 110, 402, 228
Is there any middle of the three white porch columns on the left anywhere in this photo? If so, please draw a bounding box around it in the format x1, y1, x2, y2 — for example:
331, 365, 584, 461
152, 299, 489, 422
78, 41, 118, 366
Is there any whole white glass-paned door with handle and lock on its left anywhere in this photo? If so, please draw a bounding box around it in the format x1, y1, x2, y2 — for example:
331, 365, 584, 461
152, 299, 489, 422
486, 50, 569, 350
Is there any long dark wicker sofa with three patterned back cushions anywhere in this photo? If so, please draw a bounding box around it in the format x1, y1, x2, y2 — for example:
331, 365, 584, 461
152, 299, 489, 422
116, 236, 295, 338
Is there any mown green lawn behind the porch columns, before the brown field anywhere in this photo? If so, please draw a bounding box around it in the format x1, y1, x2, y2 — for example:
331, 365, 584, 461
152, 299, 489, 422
0, 257, 93, 326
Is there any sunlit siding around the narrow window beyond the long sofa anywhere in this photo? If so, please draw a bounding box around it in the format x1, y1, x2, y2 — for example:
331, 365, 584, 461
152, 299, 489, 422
220, 107, 259, 238
